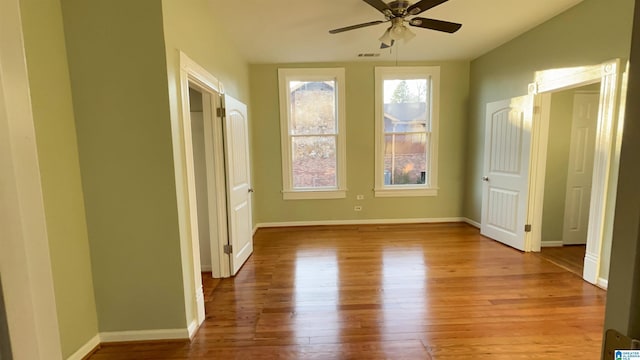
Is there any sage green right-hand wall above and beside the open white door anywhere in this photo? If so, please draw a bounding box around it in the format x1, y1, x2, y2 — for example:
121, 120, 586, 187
464, 0, 634, 221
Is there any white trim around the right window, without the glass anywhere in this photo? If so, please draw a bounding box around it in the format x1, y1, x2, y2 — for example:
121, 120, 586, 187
374, 66, 440, 197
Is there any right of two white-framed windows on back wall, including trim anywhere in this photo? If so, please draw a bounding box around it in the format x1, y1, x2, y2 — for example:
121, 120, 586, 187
375, 67, 440, 197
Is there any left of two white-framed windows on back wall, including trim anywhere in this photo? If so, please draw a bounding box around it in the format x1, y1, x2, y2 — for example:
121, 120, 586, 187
278, 68, 346, 200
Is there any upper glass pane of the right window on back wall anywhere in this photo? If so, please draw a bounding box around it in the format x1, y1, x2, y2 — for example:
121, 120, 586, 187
384, 79, 429, 132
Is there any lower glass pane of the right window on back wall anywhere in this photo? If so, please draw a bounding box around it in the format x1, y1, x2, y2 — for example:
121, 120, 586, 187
384, 134, 428, 185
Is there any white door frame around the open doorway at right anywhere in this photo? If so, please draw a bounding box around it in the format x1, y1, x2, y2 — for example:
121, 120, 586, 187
527, 59, 622, 284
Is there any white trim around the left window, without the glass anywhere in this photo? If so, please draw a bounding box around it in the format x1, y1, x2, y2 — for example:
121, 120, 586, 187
278, 68, 347, 200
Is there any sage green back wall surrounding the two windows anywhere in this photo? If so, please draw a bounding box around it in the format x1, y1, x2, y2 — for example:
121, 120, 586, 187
251, 61, 469, 223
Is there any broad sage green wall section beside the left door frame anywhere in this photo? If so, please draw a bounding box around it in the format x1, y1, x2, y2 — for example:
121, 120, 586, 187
62, 0, 187, 332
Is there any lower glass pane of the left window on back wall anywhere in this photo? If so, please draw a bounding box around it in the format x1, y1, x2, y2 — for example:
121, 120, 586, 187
291, 136, 338, 189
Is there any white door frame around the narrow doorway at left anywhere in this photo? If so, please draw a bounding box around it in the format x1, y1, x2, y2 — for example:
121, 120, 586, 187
174, 52, 230, 330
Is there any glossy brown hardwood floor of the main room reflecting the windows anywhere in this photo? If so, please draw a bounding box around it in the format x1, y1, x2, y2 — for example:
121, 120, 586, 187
91, 224, 605, 360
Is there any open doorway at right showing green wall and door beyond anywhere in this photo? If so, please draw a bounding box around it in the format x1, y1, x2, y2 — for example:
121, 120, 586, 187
541, 82, 600, 276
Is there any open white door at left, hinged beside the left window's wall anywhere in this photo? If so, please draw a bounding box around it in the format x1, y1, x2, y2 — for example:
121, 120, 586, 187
224, 95, 253, 275
